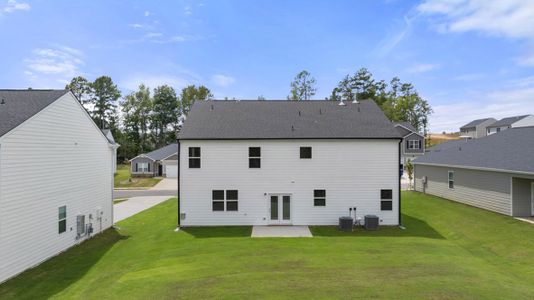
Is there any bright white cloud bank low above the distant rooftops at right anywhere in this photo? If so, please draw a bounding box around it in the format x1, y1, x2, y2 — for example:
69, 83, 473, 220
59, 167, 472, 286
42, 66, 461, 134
430, 81, 534, 132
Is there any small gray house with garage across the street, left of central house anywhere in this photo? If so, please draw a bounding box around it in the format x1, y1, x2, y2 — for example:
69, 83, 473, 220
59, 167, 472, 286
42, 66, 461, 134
130, 143, 178, 178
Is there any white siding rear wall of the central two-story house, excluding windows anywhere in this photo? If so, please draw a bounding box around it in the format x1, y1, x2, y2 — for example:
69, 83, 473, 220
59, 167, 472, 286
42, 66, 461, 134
179, 140, 399, 226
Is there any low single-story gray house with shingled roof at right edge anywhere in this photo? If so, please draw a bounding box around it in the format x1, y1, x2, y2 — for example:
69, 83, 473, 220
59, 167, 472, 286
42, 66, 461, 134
414, 127, 534, 217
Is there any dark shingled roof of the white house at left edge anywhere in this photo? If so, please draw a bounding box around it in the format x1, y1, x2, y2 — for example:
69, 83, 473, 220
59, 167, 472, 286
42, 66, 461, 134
0, 90, 68, 136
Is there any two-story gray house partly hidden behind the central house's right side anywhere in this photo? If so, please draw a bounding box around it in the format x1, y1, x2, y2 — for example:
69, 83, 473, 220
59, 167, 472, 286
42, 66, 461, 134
394, 122, 425, 167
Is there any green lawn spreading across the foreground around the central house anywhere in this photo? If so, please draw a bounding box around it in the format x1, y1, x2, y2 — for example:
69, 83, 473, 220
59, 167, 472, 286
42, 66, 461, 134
0, 192, 534, 299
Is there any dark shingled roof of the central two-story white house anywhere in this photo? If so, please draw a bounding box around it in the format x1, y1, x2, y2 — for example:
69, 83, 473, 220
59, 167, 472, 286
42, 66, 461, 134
178, 100, 401, 139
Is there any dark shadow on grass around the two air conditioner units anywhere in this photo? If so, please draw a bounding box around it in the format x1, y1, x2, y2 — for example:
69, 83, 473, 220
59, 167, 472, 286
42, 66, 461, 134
310, 214, 445, 239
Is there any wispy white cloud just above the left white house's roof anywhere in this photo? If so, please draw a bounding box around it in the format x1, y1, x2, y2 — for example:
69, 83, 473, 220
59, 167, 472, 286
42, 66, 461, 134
24, 46, 84, 83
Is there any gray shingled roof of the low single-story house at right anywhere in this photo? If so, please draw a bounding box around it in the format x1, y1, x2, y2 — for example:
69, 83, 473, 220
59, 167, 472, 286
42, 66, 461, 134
414, 127, 534, 174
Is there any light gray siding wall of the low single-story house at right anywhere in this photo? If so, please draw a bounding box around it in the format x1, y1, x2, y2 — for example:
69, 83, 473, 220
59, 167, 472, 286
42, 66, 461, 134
415, 165, 512, 215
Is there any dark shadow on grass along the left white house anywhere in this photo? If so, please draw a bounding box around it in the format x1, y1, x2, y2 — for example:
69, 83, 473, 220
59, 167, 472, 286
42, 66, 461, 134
0, 228, 128, 299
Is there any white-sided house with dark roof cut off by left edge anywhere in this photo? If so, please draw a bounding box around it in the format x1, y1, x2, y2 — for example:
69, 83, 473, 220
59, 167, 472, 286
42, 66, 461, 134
0, 90, 115, 282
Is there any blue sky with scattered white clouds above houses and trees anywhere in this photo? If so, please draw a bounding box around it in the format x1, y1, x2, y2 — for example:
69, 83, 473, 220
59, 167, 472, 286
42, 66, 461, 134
0, 0, 534, 132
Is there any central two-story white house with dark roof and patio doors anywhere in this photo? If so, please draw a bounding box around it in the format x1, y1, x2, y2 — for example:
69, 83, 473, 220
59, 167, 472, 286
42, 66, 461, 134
178, 101, 402, 226
